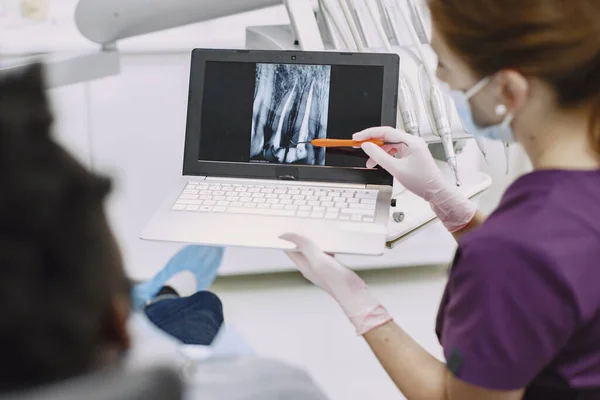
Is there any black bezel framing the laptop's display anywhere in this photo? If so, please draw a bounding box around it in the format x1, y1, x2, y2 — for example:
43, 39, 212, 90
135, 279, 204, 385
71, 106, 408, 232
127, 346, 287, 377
183, 49, 399, 185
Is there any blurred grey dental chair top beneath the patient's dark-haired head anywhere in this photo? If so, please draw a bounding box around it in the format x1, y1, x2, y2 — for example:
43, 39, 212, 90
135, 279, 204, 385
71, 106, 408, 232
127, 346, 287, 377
0, 368, 183, 400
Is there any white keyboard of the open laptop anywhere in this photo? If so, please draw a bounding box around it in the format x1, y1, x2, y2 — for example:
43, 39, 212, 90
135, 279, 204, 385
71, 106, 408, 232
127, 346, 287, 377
172, 182, 378, 222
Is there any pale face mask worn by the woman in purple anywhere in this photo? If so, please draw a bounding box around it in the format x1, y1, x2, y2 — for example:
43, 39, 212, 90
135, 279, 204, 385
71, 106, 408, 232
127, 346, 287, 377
450, 77, 516, 143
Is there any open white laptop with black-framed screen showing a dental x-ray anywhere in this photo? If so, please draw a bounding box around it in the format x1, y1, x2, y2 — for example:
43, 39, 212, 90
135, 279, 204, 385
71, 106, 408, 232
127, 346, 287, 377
141, 49, 398, 255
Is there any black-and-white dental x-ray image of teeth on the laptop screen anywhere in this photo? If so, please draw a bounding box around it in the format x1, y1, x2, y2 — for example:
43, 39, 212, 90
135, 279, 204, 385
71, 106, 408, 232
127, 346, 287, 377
250, 64, 331, 165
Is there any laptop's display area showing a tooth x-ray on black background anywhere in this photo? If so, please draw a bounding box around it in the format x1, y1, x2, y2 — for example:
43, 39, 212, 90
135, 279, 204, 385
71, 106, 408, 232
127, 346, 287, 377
199, 61, 383, 168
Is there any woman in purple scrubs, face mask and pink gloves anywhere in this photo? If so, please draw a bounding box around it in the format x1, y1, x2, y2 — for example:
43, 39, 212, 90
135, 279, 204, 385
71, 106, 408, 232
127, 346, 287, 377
284, 0, 600, 400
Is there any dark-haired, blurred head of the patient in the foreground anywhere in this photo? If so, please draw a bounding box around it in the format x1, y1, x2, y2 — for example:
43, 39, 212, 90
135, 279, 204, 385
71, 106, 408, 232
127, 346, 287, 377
0, 65, 129, 392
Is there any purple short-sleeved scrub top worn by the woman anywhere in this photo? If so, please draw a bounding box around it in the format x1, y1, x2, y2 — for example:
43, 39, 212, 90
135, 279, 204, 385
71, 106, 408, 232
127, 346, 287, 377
436, 170, 600, 400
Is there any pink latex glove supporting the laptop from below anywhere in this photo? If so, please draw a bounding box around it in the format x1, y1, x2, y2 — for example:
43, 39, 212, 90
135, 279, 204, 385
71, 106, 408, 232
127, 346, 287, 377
281, 234, 392, 336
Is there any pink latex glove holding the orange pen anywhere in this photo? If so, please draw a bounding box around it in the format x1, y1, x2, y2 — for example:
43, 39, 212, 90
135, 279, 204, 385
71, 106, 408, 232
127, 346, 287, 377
353, 127, 477, 232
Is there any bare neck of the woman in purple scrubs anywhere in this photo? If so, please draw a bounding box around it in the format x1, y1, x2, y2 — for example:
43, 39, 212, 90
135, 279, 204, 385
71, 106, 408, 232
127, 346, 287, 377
520, 106, 600, 170
